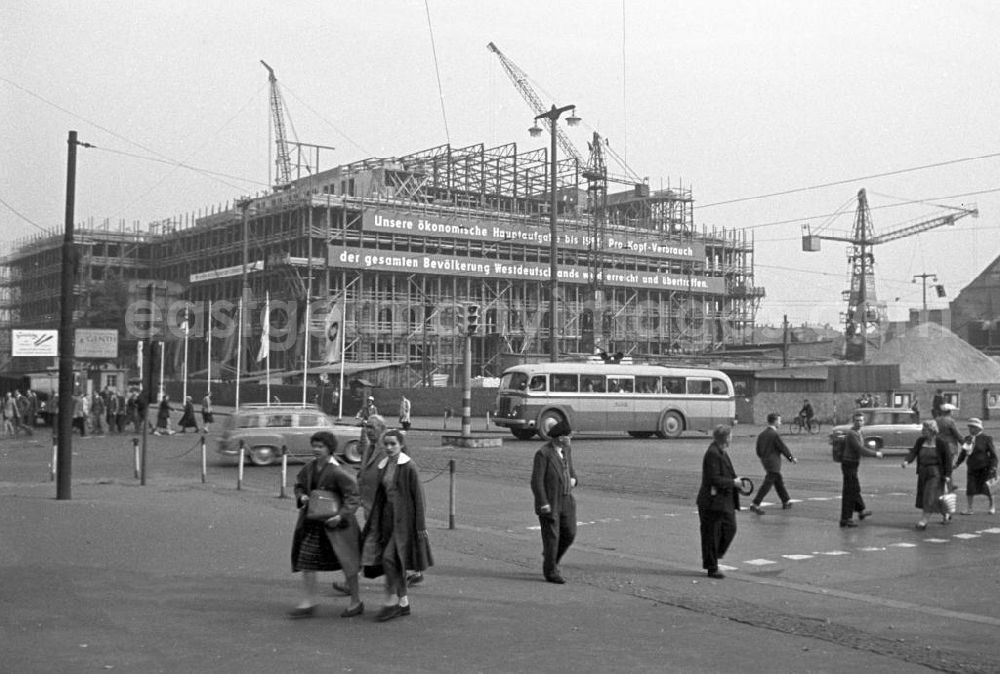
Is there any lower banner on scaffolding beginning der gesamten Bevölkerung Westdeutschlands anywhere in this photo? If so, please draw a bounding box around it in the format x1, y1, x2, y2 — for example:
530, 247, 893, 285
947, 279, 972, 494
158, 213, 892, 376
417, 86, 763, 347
329, 246, 725, 294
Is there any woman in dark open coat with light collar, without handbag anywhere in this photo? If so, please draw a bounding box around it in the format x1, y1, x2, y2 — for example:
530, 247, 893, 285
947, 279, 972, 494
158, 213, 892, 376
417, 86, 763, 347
361, 429, 434, 622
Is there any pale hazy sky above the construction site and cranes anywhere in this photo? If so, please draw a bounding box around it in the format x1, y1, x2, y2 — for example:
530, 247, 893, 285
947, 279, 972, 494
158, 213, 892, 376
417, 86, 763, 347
0, 0, 1000, 325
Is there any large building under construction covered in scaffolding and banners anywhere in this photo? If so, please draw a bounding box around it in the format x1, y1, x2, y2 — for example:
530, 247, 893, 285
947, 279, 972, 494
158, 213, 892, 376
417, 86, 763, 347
0, 139, 763, 386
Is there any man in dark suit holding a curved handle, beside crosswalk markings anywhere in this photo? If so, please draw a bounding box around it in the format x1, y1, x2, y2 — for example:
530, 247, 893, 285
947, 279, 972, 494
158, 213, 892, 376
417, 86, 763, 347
696, 424, 742, 579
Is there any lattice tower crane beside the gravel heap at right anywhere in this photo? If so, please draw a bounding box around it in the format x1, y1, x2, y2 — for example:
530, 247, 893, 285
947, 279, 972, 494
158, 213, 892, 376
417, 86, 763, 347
802, 189, 979, 362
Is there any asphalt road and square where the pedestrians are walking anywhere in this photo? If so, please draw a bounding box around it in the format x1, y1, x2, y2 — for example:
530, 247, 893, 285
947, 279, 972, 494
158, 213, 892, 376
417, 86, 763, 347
0, 420, 1000, 672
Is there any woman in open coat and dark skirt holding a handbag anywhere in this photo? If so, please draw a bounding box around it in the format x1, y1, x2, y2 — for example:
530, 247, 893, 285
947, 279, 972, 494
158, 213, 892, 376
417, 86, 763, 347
288, 431, 365, 618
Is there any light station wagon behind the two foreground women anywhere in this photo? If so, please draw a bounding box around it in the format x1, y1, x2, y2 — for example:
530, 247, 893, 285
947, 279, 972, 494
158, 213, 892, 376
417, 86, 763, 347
216, 404, 361, 466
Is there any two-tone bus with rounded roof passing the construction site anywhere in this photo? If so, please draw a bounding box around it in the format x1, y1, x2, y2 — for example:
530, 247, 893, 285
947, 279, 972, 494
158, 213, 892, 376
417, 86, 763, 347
493, 359, 736, 440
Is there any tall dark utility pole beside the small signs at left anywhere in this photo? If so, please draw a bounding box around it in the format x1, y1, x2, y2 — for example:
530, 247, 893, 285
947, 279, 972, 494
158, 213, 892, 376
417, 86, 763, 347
56, 131, 93, 501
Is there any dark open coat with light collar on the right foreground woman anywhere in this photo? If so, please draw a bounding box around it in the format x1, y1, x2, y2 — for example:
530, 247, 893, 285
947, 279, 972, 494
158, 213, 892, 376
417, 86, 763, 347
361, 453, 434, 578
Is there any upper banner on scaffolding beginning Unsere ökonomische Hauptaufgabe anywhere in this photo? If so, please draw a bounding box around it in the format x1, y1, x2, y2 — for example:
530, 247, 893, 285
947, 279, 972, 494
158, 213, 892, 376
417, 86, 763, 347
361, 207, 705, 261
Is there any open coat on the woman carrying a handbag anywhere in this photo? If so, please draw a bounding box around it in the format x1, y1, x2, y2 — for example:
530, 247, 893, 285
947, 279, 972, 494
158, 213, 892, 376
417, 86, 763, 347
292, 459, 361, 573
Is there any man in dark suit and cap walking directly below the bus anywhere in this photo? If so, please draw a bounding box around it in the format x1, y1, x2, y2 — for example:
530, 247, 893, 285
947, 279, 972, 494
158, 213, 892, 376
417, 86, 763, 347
531, 421, 576, 585
